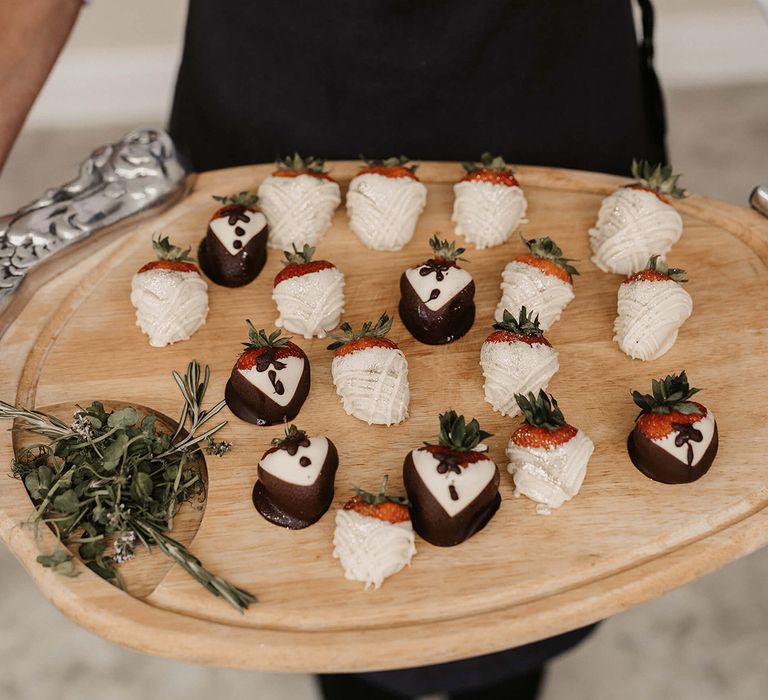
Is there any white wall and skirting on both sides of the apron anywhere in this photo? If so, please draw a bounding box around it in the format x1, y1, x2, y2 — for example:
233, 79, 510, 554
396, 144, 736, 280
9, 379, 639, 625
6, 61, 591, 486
21, 0, 768, 128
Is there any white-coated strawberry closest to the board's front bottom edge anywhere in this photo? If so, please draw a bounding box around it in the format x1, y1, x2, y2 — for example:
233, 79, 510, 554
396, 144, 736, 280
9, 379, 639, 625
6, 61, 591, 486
333, 477, 416, 589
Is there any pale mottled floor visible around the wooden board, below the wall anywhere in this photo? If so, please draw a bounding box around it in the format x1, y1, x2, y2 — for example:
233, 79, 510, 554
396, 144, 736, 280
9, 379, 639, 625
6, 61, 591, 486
0, 85, 768, 700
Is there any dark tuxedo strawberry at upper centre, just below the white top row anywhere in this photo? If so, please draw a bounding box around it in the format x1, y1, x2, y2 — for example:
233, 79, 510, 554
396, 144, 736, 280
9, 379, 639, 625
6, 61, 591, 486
399, 236, 475, 345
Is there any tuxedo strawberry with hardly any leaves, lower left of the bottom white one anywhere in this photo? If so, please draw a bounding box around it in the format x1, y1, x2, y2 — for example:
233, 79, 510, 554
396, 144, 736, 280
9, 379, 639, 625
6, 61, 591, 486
253, 425, 339, 530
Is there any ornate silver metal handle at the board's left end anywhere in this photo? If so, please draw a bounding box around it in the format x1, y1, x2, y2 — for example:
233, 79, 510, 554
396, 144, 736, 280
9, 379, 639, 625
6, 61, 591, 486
0, 129, 189, 304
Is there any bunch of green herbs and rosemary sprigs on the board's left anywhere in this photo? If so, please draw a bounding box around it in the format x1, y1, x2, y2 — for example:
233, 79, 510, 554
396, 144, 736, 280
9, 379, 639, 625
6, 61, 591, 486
0, 361, 256, 611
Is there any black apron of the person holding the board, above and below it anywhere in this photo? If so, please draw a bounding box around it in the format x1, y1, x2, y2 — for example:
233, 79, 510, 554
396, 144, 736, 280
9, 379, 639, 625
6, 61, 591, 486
170, 0, 666, 695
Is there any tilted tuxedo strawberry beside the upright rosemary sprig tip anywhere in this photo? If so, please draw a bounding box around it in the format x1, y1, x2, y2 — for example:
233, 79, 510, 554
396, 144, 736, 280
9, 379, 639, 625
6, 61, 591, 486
224, 321, 310, 425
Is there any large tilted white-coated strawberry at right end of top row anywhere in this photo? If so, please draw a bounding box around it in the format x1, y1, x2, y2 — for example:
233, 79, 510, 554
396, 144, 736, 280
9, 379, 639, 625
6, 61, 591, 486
589, 161, 686, 275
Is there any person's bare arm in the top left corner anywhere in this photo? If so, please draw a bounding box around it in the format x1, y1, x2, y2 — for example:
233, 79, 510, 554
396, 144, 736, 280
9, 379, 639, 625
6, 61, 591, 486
0, 0, 82, 170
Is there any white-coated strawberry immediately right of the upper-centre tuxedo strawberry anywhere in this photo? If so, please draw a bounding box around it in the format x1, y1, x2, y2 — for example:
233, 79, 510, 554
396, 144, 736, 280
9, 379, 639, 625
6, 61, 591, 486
496, 237, 579, 333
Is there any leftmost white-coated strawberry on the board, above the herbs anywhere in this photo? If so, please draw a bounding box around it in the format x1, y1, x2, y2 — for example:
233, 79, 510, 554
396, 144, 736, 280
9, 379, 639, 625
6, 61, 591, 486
131, 236, 208, 348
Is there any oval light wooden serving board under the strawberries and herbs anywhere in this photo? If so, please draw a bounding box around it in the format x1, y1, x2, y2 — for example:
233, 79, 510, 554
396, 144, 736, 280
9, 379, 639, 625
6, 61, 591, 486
0, 162, 768, 671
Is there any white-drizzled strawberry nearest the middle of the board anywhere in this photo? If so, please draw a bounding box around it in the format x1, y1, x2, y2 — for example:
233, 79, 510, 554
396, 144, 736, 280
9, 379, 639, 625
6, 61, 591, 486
328, 314, 410, 425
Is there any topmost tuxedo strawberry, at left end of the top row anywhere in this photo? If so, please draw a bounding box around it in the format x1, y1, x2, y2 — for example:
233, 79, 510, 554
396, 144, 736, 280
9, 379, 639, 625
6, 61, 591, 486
198, 192, 267, 287
